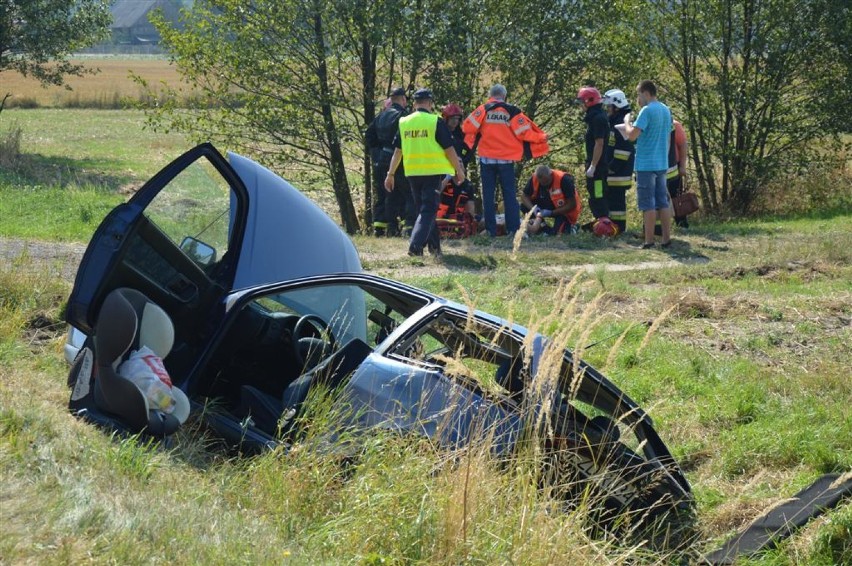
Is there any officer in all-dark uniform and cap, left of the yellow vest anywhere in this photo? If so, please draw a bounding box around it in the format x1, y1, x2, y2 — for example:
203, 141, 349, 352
364, 87, 416, 236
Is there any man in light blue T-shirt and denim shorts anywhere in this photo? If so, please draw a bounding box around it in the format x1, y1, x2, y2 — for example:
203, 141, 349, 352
616, 80, 672, 249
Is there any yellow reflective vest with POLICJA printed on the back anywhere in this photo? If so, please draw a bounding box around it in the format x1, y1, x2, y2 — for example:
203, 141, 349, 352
399, 111, 455, 177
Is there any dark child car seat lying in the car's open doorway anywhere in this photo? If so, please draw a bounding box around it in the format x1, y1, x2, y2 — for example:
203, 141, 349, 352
69, 288, 190, 436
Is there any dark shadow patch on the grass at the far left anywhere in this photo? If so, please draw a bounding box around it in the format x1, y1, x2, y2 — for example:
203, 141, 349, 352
0, 154, 138, 193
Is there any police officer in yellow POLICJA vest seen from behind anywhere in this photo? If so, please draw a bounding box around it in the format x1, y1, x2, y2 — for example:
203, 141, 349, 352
385, 88, 465, 257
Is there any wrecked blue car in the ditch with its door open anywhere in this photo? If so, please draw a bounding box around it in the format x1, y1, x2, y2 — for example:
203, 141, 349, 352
66, 144, 692, 532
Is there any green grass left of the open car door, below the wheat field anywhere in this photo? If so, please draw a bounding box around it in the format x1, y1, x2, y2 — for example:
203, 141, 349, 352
0, 109, 188, 241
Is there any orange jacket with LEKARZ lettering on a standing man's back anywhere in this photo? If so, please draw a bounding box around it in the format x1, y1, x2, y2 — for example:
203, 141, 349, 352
462, 98, 550, 161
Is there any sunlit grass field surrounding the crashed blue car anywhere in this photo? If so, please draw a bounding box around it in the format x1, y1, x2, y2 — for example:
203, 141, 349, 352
0, 110, 852, 565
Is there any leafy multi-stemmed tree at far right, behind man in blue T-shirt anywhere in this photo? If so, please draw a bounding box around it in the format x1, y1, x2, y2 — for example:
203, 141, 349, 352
644, 0, 852, 212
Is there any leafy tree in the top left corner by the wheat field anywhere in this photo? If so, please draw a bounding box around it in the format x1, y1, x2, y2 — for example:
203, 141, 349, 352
0, 0, 112, 111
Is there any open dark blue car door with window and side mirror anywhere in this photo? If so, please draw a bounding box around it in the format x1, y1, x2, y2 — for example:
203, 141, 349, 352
66, 144, 249, 378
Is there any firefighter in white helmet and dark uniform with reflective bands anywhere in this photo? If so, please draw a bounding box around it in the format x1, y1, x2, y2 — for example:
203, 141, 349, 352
602, 88, 636, 234
